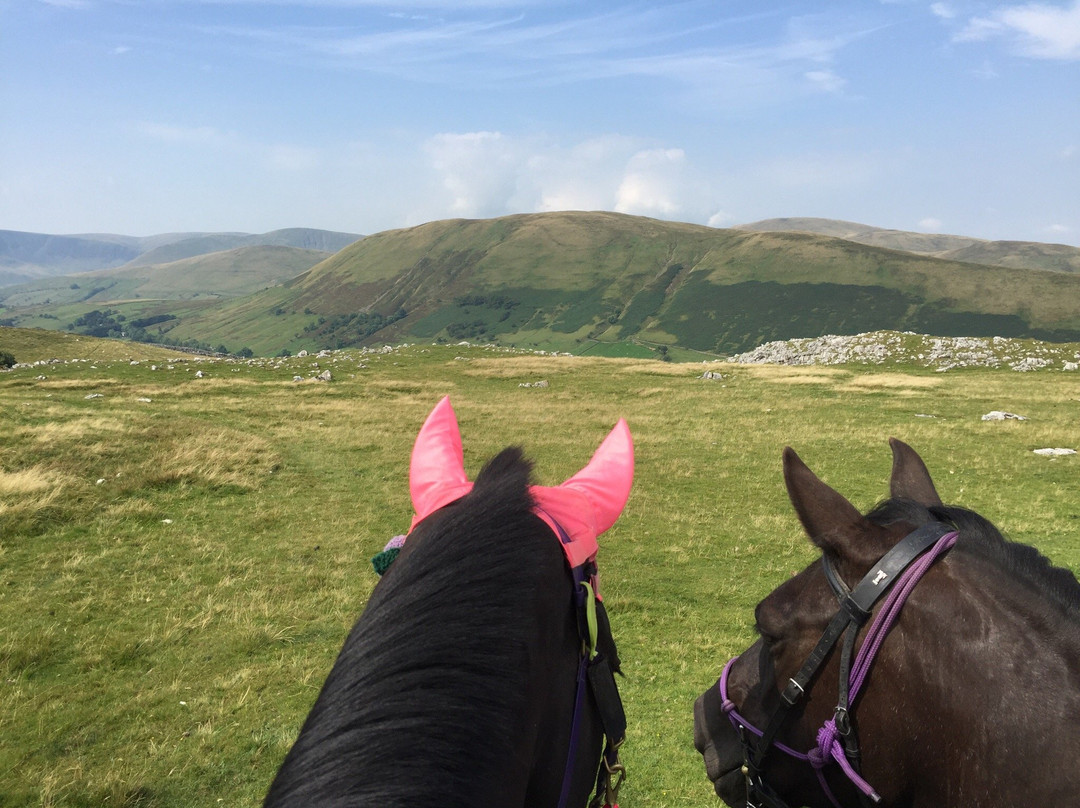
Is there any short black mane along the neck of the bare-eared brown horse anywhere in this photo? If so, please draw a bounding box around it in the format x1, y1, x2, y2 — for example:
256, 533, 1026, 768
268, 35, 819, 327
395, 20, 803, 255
866, 499, 1080, 621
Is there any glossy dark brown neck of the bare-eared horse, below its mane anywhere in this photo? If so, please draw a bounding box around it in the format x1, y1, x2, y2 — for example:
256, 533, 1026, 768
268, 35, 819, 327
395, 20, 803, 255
858, 558, 1080, 808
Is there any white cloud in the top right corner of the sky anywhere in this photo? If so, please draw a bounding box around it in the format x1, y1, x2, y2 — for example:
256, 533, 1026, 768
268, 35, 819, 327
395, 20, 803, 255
956, 0, 1080, 60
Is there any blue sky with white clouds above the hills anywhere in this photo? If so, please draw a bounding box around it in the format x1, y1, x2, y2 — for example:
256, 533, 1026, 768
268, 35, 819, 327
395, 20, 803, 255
0, 0, 1080, 245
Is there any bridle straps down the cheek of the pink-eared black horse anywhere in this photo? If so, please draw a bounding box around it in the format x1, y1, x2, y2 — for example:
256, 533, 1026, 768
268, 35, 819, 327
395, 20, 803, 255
556, 523, 626, 808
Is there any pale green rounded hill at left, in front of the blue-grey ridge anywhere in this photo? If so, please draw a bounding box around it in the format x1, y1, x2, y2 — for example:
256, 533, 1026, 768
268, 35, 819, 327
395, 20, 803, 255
0, 246, 330, 308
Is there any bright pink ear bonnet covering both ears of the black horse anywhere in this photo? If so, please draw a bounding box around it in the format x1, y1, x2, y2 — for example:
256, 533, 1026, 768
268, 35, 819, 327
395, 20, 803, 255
409, 396, 634, 567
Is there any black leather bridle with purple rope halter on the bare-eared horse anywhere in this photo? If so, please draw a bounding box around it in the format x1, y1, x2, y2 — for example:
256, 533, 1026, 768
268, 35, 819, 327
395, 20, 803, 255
718, 522, 957, 808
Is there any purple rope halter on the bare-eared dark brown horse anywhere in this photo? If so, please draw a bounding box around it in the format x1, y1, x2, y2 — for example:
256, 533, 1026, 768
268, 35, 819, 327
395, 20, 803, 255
718, 530, 958, 808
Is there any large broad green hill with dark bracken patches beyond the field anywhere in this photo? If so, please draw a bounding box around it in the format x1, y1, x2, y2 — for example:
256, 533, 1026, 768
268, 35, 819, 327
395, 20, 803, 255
2, 213, 1080, 358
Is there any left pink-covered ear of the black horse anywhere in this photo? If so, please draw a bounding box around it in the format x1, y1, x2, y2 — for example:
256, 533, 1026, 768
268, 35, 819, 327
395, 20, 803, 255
408, 395, 472, 527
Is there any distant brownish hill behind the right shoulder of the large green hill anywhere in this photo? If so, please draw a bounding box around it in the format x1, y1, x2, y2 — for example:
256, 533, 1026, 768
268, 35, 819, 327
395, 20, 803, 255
737, 217, 1080, 272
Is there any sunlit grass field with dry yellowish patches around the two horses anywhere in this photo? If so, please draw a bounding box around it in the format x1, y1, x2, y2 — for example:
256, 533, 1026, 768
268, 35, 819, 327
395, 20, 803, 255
0, 337, 1080, 808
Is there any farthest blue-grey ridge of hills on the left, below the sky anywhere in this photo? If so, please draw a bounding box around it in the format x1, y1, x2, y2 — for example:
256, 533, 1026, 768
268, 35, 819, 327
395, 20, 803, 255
0, 228, 362, 286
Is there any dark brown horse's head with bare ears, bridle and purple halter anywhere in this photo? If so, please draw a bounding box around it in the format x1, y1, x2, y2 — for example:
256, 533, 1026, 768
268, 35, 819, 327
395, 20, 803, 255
694, 440, 1000, 808
